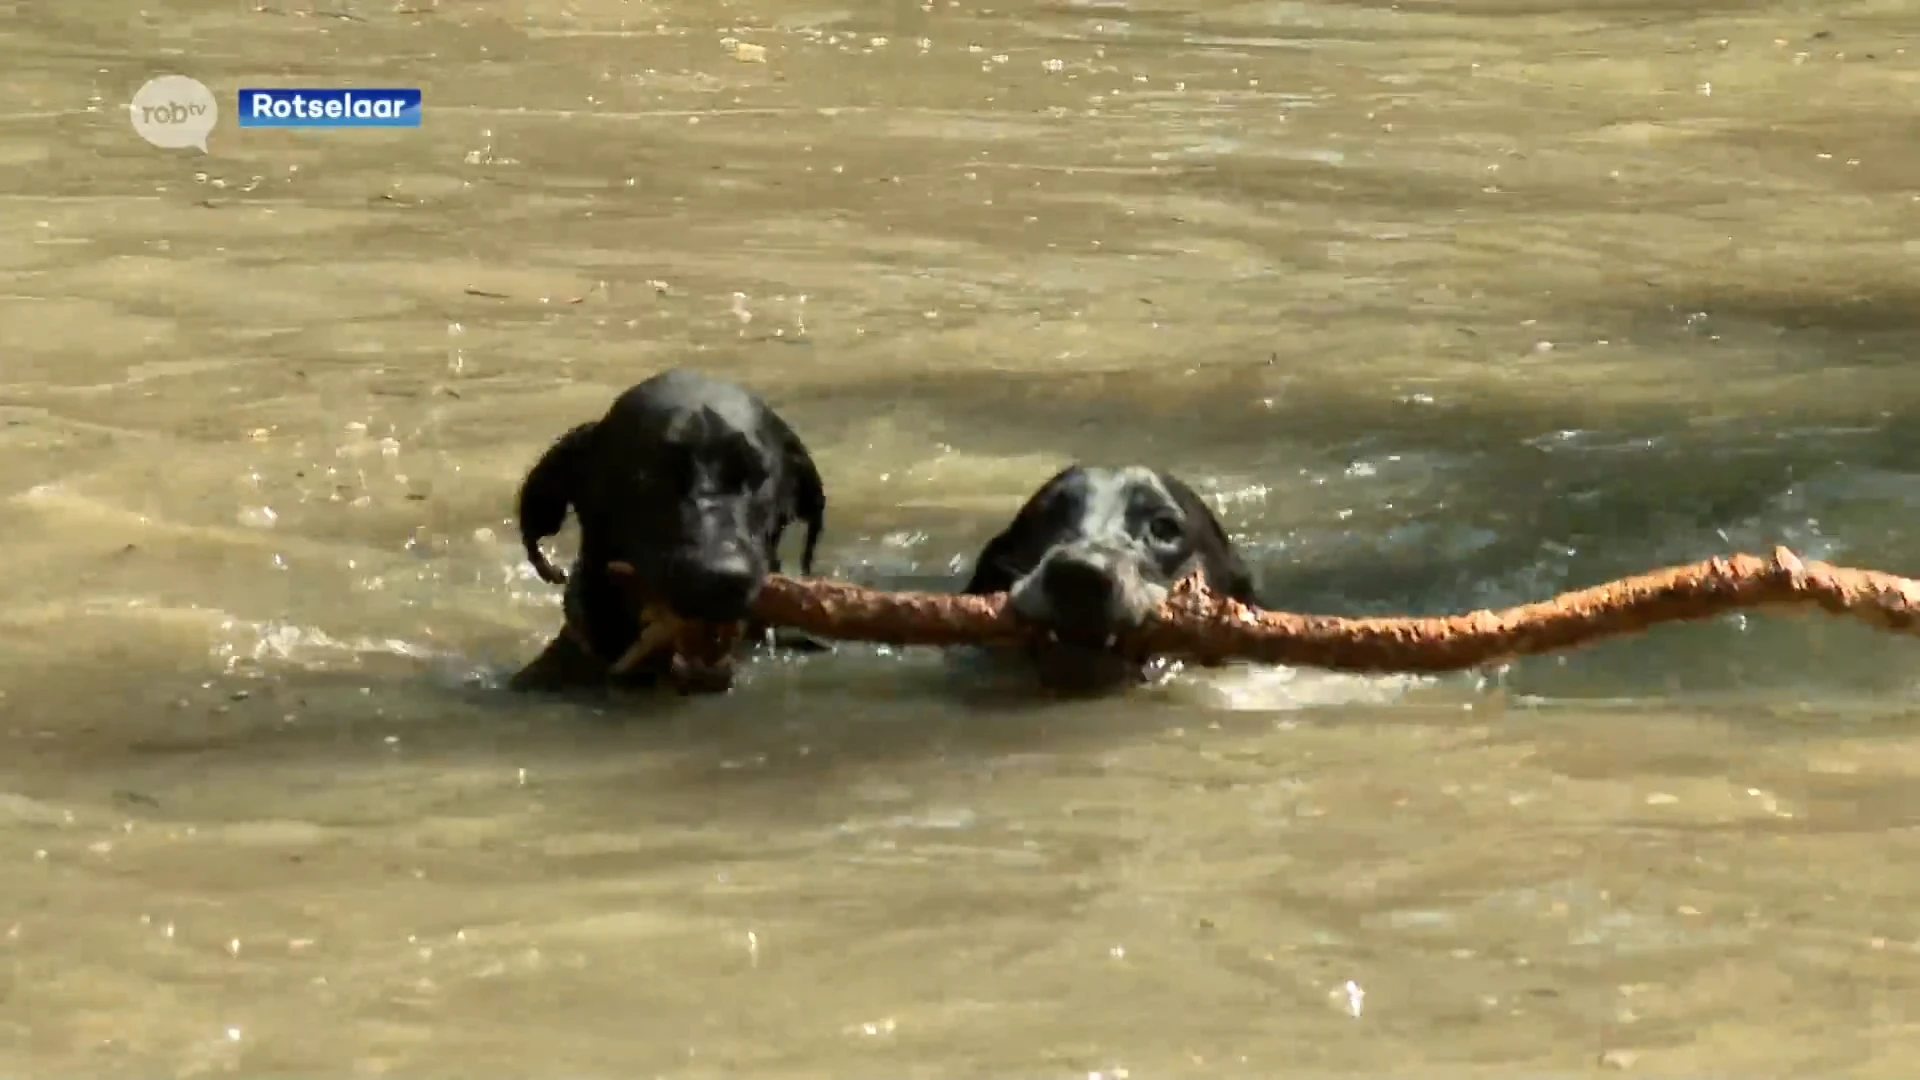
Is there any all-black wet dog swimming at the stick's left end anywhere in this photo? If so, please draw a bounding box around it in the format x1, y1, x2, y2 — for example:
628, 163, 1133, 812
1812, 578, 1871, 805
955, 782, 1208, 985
511, 371, 826, 690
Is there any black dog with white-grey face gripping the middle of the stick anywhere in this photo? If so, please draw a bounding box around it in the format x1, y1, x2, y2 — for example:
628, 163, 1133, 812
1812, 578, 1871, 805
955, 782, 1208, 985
964, 465, 1256, 692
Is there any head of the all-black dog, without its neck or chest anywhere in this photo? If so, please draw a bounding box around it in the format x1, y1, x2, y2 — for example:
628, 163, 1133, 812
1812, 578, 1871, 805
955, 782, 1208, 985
520, 371, 826, 623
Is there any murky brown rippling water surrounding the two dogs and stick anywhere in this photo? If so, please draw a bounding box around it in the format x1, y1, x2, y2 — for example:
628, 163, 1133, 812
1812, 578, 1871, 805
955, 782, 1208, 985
0, 0, 1920, 1078
